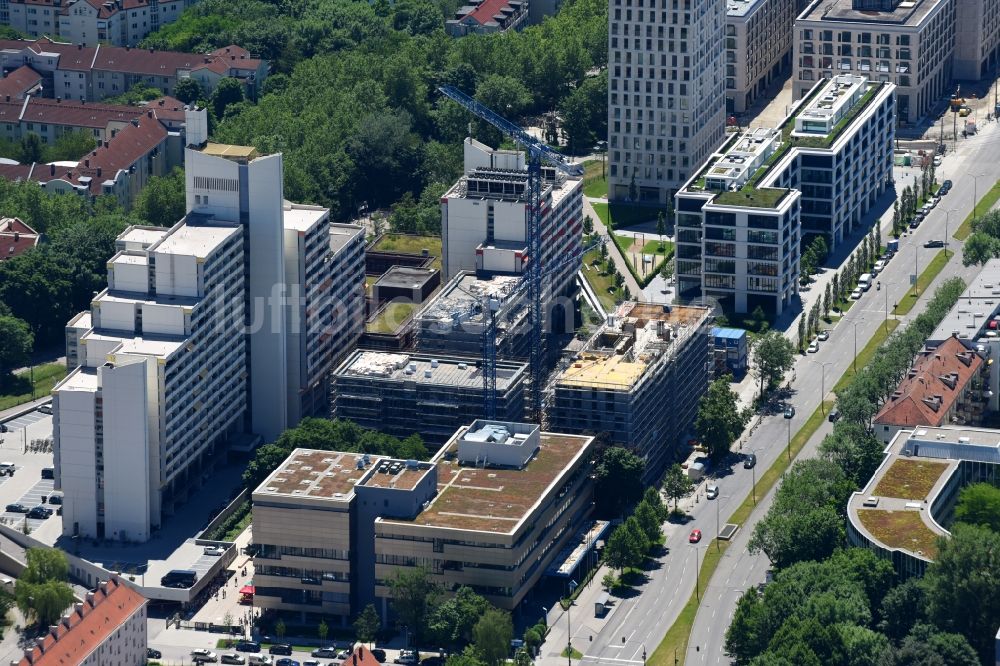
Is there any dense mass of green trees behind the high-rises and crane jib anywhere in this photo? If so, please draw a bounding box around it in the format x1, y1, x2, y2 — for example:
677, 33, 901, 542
136, 0, 607, 228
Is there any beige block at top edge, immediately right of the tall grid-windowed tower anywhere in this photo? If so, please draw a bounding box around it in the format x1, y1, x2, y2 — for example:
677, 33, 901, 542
726, 0, 795, 113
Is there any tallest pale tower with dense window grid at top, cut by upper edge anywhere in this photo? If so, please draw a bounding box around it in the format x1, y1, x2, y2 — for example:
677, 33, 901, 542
608, 0, 726, 204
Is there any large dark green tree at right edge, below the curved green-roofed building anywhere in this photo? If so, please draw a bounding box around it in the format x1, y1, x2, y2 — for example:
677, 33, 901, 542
924, 523, 1000, 663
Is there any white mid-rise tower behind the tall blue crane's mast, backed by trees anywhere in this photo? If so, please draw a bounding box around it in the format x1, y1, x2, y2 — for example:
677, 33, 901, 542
441, 138, 583, 306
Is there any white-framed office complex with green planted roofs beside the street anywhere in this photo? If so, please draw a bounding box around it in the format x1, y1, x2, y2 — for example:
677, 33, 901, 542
676, 75, 895, 314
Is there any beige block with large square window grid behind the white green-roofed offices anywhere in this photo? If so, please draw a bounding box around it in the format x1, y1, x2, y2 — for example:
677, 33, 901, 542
793, 0, 952, 124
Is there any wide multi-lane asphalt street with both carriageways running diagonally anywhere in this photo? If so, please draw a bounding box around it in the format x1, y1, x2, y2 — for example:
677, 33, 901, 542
572, 115, 1000, 664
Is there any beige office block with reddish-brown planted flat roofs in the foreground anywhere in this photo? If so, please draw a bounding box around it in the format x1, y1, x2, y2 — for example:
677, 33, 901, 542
253, 421, 594, 622
